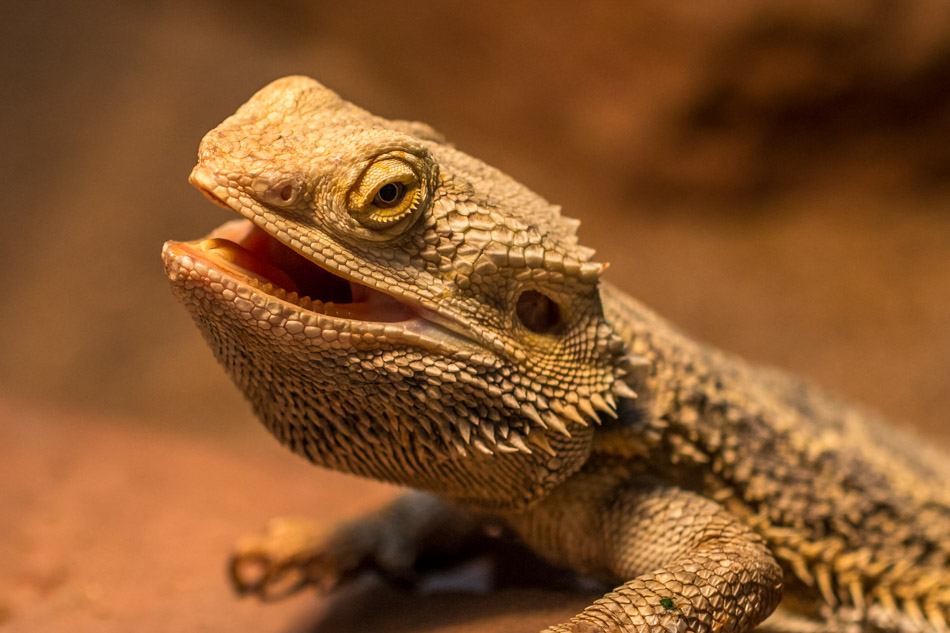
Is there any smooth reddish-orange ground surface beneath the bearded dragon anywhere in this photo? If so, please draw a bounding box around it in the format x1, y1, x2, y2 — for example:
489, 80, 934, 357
0, 402, 600, 633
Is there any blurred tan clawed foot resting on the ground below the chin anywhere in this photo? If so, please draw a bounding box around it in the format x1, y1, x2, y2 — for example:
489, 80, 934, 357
229, 518, 346, 600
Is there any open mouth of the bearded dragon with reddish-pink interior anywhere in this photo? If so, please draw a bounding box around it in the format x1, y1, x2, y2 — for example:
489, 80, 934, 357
162, 165, 488, 360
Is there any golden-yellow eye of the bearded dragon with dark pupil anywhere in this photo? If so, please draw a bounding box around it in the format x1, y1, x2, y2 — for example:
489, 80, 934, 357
348, 152, 425, 230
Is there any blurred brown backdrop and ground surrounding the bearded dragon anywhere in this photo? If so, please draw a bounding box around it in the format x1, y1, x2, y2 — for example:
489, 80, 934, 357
0, 0, 950, 631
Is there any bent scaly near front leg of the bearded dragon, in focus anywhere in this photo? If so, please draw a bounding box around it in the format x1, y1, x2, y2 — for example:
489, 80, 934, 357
512, 470, 782, 633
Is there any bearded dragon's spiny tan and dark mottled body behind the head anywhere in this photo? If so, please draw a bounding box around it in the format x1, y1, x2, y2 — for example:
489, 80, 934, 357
604, 287, 950, 608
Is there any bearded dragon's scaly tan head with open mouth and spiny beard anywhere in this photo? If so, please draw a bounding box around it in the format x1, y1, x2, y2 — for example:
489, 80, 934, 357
163, 77, 633, 509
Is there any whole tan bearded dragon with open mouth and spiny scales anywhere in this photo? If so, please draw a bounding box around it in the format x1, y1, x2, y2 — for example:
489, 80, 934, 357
163, 77, 950, 633
